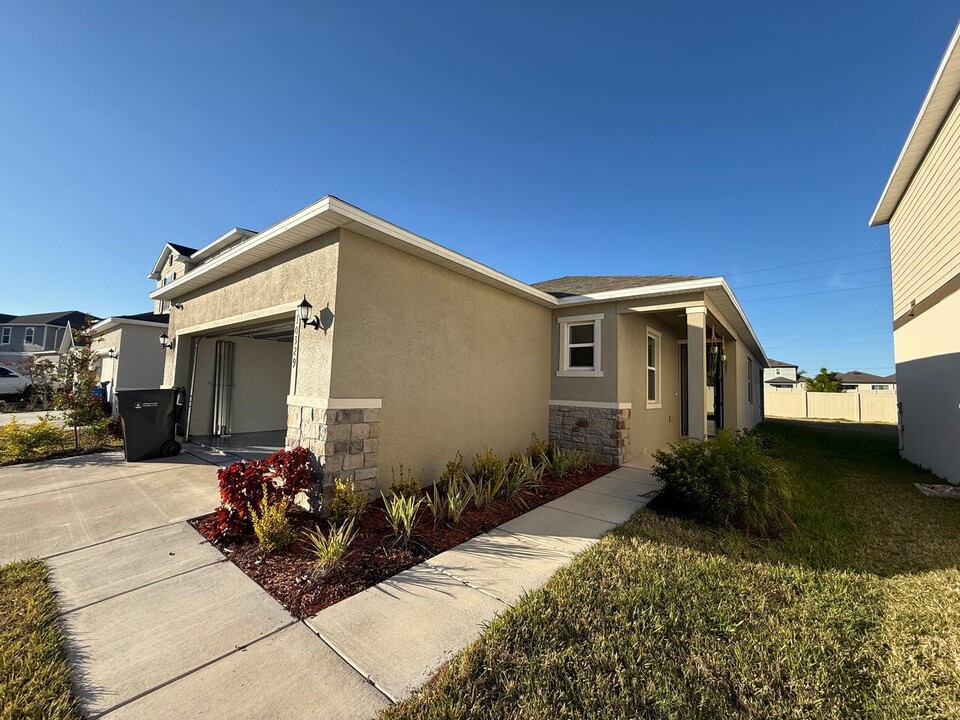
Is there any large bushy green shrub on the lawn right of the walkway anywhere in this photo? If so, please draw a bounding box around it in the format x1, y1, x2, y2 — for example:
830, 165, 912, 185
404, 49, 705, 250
653, 430, 794, 537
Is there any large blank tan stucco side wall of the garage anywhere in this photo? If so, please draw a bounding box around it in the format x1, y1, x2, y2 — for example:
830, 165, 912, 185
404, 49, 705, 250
330, 230, 552, 486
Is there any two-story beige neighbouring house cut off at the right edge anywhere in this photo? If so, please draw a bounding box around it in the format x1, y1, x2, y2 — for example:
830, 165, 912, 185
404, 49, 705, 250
870, 23, 960, 483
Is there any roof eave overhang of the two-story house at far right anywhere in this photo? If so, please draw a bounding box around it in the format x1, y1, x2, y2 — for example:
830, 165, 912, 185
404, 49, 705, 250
870, 25, 960, 227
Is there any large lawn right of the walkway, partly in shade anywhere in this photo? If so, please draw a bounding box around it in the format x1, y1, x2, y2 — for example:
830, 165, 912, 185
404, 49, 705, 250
384, 421, 960, 719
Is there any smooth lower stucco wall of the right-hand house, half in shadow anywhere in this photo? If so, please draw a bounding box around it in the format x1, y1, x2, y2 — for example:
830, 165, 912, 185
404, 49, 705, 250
893, 292, 960, 483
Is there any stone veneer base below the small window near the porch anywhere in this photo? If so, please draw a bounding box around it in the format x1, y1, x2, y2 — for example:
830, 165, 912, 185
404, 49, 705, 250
550, 404, 630, 465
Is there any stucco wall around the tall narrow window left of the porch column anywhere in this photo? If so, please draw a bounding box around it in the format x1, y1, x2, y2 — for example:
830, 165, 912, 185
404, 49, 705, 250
617, 314, 681, 458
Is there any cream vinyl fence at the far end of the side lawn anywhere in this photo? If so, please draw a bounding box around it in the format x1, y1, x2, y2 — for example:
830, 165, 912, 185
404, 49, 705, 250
763, 390, 897, 424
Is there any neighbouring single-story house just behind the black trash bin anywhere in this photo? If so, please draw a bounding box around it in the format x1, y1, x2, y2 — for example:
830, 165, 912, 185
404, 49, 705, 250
90, 312, 169, 402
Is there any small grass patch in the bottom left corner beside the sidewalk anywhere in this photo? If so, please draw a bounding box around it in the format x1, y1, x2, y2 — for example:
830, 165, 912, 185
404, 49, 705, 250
0, 560, 82, 720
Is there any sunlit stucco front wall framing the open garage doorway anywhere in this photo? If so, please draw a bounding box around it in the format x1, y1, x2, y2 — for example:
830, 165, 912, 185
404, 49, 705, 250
164, 230, 339, 402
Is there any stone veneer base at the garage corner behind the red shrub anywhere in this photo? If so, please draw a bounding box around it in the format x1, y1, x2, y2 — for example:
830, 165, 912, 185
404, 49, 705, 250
286, 398, 380, 514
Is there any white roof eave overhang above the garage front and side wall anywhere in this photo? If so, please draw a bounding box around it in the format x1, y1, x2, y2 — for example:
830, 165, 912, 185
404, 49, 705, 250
150, 195, 557, 307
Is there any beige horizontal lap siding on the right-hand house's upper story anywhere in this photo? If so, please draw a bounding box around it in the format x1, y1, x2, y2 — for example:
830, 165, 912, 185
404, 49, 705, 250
890, 92, 960, 320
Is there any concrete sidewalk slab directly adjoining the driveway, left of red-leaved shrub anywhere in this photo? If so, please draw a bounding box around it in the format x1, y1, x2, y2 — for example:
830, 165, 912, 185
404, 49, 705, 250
47, 523, 226, 612
